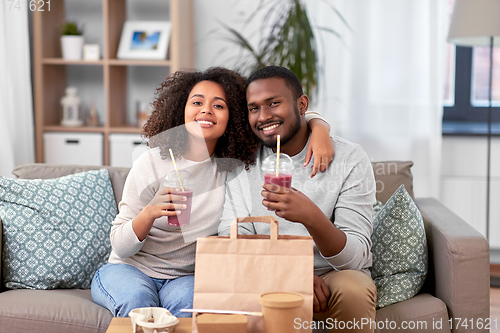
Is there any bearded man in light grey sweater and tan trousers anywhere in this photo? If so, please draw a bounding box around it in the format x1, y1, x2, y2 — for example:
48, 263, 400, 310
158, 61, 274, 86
219, 66, 376, 332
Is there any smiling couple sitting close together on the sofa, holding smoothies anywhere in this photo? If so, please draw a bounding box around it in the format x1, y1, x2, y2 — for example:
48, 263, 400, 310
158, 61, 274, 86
92, 66, 376, 330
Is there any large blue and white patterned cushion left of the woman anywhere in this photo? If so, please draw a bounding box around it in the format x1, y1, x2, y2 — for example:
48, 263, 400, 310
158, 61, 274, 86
0, 169, 117, 289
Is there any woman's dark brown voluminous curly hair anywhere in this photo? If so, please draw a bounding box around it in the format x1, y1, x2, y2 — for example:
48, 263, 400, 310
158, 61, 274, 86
142, 67, 258, 171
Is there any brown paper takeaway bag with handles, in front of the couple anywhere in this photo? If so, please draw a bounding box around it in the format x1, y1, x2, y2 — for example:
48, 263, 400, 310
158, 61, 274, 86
193, 216, 314, 333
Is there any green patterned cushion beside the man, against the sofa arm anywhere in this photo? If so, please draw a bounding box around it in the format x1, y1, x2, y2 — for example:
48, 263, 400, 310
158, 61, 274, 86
371, 185, 428, 308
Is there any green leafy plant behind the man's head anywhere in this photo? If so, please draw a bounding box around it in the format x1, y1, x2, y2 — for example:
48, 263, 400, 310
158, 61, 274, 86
221, 0, 350, 96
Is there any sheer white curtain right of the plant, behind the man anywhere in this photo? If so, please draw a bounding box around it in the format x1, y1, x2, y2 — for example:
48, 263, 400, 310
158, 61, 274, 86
307, 0, 448, 198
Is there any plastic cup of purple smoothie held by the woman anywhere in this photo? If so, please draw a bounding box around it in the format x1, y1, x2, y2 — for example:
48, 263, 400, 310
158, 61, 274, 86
163, 170, 195, 227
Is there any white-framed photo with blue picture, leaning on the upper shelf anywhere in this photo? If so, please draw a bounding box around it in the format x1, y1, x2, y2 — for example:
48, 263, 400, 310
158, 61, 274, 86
116, 21, 172, 60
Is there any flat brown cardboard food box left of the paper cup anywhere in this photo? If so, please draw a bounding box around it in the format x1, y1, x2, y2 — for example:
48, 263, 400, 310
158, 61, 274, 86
196, 313, 248, 333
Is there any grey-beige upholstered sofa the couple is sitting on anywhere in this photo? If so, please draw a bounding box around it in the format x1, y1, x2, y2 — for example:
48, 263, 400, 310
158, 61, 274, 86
0, 162, 490, 333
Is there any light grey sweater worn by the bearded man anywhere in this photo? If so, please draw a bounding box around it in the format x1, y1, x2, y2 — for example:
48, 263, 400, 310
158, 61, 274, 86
219, 137, 375, 275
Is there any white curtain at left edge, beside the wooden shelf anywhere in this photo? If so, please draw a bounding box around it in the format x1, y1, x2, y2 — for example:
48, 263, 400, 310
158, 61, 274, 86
0, 1, 35, 177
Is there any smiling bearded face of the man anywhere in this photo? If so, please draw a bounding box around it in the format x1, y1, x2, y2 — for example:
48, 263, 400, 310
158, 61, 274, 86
247, 78, 305, 148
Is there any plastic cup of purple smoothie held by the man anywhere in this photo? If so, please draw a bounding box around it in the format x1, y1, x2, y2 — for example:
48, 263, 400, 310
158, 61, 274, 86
261, 153, 293, 209
